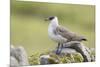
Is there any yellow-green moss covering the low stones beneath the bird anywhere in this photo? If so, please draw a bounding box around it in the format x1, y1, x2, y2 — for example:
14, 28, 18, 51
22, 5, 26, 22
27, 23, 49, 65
29, 51, 95, 65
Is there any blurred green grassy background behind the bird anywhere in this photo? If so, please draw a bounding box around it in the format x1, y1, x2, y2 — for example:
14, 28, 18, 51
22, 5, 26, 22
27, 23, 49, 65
11, 0, 95, 55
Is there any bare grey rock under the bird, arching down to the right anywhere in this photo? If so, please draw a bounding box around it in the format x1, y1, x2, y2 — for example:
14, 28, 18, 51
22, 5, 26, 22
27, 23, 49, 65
54, 41, 91, 62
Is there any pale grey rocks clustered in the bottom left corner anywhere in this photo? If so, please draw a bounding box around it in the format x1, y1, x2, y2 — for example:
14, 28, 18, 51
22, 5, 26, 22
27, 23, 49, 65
10, 46, 29, 66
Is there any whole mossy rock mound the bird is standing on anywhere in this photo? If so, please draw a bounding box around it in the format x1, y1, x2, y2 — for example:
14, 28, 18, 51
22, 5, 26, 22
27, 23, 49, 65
29, 41, 95, 65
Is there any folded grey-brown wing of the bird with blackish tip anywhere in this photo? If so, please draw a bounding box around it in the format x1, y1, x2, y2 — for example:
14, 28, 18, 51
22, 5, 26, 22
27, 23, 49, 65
56, 26, 87, 41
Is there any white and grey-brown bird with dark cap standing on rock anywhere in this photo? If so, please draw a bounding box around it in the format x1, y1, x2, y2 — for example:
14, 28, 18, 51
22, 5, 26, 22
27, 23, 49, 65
45, 16, 87, 54
